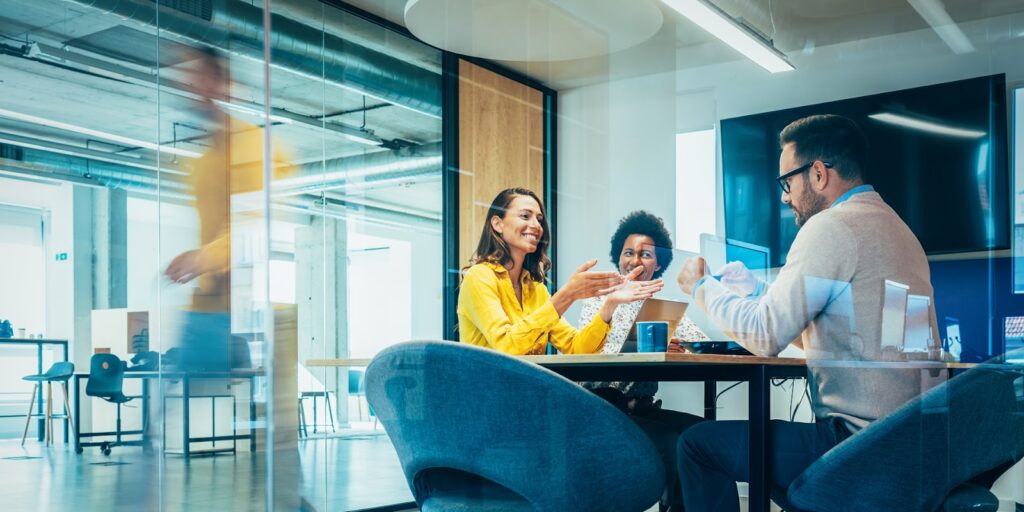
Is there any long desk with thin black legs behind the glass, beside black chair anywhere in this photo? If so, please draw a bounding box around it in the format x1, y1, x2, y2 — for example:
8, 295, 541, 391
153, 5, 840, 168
73, 370, 264, 458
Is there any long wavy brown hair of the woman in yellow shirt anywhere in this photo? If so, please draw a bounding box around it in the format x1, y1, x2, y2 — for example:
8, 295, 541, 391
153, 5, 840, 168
463, 188, 551, 283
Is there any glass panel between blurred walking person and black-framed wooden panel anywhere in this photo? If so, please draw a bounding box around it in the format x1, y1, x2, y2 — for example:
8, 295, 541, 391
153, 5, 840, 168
258, 2, 442, 510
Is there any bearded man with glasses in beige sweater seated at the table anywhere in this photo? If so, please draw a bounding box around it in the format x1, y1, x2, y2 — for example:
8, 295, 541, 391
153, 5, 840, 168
678, 116, 939, 511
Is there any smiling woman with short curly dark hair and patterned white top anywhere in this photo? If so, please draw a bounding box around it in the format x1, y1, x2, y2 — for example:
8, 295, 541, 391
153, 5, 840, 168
580, 210, 708, 511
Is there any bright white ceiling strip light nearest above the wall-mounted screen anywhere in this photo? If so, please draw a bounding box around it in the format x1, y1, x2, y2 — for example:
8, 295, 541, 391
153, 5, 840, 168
662, 0, 795, 73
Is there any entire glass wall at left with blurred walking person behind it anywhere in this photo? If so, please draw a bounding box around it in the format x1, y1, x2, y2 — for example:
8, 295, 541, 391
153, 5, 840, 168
0, 1, 443, 510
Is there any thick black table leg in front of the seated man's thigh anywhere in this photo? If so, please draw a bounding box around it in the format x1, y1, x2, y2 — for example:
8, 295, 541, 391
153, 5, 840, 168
748, 365, 771, 512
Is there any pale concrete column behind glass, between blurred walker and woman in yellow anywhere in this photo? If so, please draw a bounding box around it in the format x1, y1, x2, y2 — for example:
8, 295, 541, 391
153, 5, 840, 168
295, 217, 349, 427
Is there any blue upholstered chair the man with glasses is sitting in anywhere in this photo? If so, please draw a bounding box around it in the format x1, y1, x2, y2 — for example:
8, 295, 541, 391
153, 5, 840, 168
779, 367, 1024, 512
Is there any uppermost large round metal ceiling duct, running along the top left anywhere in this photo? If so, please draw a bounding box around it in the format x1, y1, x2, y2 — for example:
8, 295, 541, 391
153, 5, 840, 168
71, 0, 441, 118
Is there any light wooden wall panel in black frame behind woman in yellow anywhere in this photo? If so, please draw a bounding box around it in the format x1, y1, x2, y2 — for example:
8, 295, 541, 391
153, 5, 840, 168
459, 59, 544, 266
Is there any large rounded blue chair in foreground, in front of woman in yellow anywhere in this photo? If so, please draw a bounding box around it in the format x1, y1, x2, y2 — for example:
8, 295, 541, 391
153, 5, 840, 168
366, 341, 665, 512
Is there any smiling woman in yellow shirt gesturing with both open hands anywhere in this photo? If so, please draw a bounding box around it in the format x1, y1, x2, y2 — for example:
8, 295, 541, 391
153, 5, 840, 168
458, 188, 664, 355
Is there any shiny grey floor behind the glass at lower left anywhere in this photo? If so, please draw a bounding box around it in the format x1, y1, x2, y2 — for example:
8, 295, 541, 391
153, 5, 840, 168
0, 431, 412, 512
